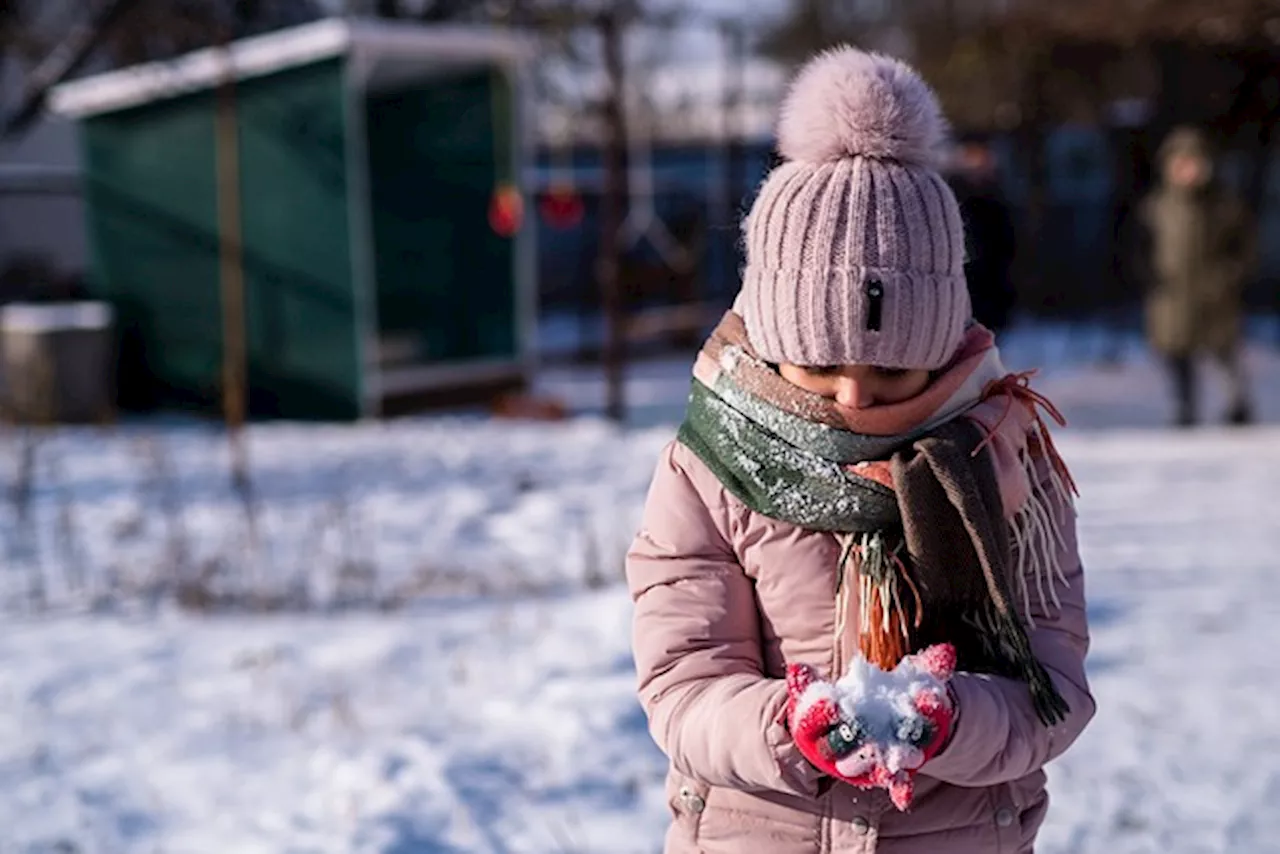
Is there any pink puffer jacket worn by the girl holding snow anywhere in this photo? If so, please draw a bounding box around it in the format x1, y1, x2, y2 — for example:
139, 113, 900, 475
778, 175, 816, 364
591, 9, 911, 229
627, 443, 1094, 854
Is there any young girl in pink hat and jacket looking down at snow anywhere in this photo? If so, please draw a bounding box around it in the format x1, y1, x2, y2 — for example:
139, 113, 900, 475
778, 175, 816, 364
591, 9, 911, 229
627, 49, 1094, 854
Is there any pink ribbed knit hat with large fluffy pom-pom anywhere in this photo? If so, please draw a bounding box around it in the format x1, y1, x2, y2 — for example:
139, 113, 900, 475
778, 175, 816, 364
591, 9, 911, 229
735, 47, 970, 370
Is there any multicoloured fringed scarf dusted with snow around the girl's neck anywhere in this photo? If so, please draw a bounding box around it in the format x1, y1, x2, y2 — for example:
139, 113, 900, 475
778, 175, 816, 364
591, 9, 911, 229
680, 312, 1075, 725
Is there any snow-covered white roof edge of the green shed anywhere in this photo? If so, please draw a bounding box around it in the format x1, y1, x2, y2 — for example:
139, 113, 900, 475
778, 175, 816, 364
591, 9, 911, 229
49, 18, 526, 118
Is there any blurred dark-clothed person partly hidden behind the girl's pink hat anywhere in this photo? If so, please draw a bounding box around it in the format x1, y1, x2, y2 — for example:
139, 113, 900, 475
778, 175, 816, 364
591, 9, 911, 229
950, 137, 1016, 333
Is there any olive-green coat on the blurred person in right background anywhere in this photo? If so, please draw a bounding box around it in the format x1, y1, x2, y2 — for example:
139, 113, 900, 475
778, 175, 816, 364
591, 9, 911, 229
1138, 131, 1256, 356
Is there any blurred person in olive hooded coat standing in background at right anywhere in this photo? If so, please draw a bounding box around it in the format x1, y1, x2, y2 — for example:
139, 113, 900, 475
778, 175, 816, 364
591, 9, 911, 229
1138, 127, 1256, 426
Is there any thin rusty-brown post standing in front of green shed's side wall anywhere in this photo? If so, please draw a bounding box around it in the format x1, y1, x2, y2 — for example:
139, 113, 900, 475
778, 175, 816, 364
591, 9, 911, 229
215, 32, 257, 540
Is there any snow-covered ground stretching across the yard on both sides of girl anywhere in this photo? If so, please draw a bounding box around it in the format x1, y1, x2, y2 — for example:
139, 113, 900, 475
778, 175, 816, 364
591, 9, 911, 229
0, 330, 1280, 854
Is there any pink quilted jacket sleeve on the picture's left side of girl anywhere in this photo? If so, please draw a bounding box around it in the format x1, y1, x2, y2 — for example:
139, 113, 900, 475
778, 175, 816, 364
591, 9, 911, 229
626, 443, 819, 795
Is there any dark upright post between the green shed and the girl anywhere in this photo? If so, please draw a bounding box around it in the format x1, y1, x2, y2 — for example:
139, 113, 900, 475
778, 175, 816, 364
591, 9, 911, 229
598, 6, 627, 423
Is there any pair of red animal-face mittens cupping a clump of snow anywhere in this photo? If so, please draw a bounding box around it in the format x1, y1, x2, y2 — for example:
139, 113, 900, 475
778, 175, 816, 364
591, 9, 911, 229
787, 644, 956, 810
